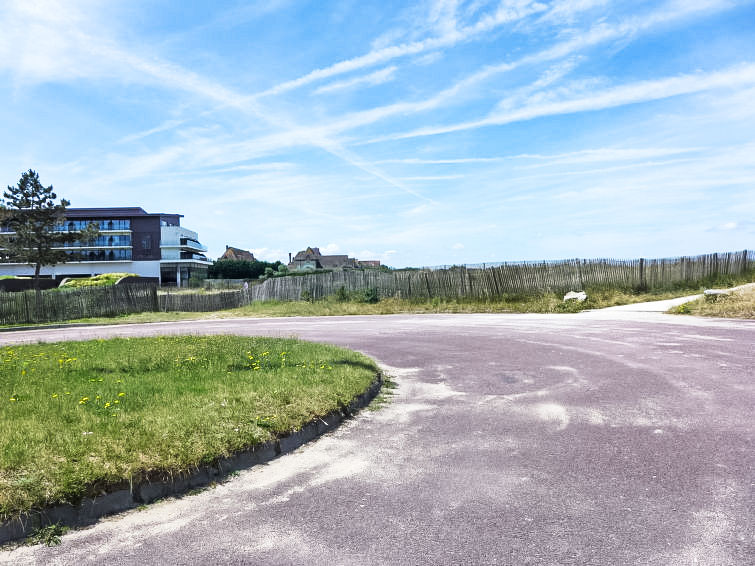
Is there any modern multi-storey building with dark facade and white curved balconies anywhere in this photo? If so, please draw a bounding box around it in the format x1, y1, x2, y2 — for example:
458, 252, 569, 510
0, 207, 212, 287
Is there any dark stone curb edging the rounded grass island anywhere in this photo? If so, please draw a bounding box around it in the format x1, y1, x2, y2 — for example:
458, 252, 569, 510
0, 371, 384, 545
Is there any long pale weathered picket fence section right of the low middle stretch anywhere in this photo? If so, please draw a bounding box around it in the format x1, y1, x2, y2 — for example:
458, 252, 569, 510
249, 250, 755, 301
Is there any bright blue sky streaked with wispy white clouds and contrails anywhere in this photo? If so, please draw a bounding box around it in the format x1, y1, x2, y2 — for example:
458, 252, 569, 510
0, 0, 755, 266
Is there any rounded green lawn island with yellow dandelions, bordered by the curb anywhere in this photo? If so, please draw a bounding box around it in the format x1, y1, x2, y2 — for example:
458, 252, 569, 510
0, 336, 378, 519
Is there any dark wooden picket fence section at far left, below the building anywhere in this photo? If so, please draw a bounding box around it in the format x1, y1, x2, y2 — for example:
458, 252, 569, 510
0, 285, 158, 324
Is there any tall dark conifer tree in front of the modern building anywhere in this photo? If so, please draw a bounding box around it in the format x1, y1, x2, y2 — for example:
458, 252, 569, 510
0, 169, 99, 295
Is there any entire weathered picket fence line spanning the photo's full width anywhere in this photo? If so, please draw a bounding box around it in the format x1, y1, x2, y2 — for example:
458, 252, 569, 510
0, 250, 755, 324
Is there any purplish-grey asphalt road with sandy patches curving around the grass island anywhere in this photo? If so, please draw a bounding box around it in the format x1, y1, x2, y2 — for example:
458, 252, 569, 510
0, 307, 755, 566
